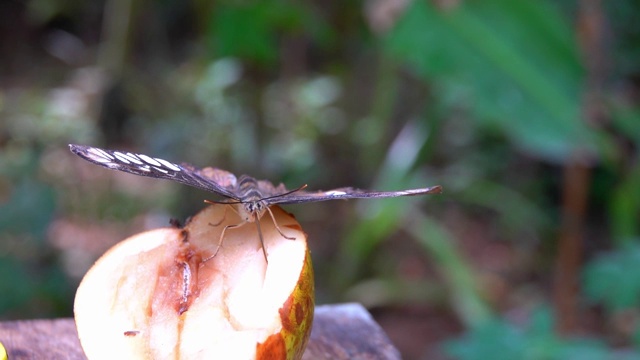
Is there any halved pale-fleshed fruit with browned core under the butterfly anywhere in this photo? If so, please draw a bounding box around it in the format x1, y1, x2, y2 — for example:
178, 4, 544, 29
75, 205, 314, 359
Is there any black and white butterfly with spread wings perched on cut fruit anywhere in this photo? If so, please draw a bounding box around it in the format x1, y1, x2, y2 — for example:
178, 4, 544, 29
69, 144, 442, 261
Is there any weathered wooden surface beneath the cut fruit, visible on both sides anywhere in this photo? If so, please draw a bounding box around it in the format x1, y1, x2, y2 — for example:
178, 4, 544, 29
0, 303, 400, 360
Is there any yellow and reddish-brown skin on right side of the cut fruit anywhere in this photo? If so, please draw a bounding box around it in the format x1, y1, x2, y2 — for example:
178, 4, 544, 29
256, 249, 315, 360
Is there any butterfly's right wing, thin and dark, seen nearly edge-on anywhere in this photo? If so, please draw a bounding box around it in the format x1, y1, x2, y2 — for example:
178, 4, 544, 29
268, 186, 442, 205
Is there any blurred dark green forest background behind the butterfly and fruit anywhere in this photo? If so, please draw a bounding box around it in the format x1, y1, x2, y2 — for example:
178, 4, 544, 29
0, 0, 640, 359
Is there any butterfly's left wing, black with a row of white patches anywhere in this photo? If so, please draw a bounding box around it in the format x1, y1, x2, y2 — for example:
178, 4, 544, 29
69, 144, 240, 200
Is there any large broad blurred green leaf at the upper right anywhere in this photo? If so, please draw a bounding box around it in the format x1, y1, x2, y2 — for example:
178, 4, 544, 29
384, 0, 609, 161
